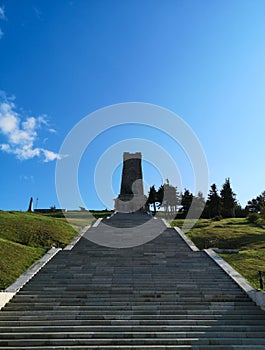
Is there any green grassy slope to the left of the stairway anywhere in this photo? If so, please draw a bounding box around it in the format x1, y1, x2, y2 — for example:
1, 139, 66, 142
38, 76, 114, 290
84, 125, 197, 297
0, 211, 82, 290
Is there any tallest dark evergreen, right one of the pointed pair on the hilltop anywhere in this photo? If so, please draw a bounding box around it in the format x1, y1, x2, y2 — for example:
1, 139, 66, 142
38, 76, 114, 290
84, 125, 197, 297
220, 178, 237, 218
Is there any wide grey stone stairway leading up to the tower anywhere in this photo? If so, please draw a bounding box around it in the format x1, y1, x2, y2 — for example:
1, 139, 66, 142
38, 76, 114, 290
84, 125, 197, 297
0, 214, 265, 350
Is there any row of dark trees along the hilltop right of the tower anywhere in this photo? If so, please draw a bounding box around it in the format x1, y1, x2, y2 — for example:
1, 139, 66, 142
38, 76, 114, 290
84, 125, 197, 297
147, 178, 265, 218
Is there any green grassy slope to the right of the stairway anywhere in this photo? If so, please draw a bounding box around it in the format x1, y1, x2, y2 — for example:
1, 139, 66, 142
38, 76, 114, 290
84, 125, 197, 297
171, 218, 265, 288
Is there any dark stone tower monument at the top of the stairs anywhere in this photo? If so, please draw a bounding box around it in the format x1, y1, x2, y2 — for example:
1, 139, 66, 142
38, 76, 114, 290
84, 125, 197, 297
115, 152, 147, 213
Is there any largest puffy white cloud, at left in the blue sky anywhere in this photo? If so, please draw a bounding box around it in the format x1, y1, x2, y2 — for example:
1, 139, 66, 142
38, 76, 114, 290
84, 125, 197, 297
0, 93, 61, 163
